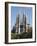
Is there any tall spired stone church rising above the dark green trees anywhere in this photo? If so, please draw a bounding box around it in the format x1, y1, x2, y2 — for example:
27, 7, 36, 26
16, 14, 28, 34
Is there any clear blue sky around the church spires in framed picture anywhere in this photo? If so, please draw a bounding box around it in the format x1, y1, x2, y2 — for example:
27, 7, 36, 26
11, 6, 32, 28
